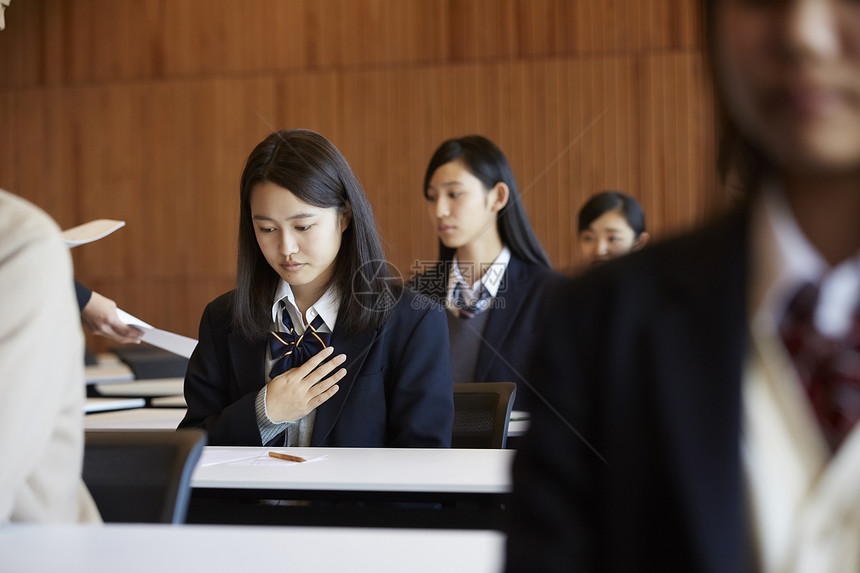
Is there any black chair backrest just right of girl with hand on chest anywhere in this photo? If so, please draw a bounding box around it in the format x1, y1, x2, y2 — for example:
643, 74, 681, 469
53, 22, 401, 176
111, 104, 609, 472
451, 382, 517, 448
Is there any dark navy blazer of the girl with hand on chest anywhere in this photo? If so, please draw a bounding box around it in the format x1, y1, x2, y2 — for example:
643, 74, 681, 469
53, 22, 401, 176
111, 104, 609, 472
180, 289, 454, 448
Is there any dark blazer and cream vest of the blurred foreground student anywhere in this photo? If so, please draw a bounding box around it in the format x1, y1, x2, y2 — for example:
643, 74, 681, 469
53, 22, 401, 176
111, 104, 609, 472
507, 189, 860, 573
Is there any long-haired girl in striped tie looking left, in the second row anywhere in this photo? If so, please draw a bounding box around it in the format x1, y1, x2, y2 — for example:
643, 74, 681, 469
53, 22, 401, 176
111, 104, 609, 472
412, 135, 561, 409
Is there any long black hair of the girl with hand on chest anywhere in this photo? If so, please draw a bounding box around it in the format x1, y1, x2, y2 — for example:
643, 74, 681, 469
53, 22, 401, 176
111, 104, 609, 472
233, 129, 399, 340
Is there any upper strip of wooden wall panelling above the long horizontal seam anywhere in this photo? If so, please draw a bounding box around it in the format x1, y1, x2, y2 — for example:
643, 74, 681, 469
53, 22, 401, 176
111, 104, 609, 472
0, 0, 701, 86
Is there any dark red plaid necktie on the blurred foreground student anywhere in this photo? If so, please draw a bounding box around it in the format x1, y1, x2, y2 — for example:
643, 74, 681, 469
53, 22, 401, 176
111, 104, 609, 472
780, 283, 860, 452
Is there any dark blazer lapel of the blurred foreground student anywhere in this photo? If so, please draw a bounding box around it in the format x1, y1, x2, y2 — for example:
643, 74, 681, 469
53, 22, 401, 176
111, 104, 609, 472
652, 209, 748, 571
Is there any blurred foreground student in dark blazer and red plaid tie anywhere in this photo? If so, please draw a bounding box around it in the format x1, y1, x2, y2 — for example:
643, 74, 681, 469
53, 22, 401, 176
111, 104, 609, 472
507, 0, 860, 573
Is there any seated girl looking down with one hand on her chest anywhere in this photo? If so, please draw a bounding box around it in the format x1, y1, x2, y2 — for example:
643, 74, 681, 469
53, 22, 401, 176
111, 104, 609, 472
180, 130, 453, 447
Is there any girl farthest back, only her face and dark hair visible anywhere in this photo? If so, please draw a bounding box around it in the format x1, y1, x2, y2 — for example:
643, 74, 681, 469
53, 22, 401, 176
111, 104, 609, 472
578, 191, 650, 266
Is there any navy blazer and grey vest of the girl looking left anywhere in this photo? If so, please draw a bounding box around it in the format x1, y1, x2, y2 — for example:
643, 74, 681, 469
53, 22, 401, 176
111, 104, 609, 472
410, 248, 562, 410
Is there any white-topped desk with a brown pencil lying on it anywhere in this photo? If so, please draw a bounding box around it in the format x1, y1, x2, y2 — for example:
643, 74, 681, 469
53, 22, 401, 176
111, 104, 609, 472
188, 447, 515, 529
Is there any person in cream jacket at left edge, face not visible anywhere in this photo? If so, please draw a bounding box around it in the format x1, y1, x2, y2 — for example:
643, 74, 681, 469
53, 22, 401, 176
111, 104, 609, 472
0, 190, 100, 523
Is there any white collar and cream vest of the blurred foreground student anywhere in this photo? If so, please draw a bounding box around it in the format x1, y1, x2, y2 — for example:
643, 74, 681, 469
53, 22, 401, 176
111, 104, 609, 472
742, 187, 860, 573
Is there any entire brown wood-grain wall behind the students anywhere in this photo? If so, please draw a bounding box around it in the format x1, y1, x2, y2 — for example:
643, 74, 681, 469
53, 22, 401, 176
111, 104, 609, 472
0, 0, 722, 347
